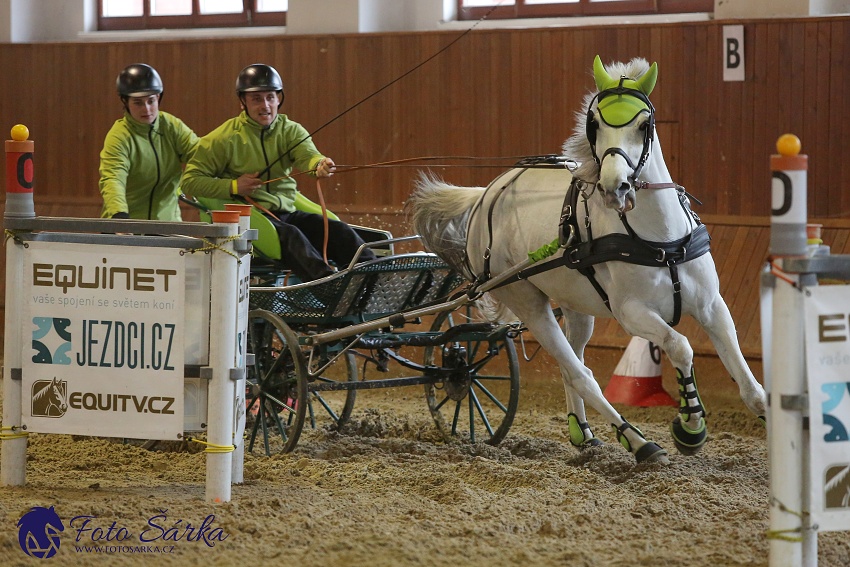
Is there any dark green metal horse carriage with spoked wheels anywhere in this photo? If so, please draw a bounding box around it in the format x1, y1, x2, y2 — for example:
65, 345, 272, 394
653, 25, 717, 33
246, 233, 520, 455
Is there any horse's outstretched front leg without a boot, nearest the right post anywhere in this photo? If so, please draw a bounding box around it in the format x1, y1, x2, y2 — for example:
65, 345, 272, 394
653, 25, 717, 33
694, 294, 767, 420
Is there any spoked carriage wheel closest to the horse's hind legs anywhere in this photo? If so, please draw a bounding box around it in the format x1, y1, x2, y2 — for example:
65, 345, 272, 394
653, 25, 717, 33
424, 312, 519, 445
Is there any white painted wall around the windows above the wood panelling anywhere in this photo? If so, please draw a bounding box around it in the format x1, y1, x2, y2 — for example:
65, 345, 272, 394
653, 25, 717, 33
0, 0, 850, 43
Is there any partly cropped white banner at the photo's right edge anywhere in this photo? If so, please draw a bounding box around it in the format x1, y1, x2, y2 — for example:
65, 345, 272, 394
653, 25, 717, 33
804, 285, 850, 531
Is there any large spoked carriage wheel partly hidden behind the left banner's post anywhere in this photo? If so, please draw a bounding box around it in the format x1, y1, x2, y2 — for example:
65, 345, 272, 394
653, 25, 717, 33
245, 309, 307, 455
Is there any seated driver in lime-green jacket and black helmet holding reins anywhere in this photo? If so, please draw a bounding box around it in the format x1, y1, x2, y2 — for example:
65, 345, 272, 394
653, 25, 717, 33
181, 64, 375, 281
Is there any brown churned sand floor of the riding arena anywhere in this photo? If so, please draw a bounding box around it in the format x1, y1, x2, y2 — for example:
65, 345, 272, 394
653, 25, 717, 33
0, 349, 850, 567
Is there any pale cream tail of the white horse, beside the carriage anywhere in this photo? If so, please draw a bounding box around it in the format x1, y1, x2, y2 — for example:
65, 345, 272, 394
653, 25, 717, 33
405, 172, 484, 277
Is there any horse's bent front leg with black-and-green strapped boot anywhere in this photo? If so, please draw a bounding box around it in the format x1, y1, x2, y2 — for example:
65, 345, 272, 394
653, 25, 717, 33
616, 301, 708, 455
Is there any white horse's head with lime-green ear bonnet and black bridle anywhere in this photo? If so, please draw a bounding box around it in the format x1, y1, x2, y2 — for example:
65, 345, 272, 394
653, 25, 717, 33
584, 55, 658, 212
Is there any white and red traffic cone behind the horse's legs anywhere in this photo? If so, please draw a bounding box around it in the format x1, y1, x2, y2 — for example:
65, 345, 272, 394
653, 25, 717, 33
604, 337, 678, 407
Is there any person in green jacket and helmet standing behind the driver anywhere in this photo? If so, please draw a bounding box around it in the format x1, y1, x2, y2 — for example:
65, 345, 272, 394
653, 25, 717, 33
99, 63, 198, 221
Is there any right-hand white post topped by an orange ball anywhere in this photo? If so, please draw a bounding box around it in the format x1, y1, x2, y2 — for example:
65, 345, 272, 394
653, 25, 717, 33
766, 134, 817, 567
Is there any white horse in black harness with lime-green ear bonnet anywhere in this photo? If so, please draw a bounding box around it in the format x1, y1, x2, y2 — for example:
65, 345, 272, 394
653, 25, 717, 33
407, 56, 766, 462
